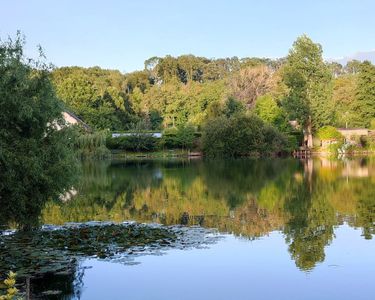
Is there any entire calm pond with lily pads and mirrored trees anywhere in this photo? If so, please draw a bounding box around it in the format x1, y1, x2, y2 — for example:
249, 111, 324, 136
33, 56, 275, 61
0, 158, 375, 300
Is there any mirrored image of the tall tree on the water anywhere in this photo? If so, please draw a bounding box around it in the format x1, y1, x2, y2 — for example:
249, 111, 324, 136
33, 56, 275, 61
284, 162, 337, 270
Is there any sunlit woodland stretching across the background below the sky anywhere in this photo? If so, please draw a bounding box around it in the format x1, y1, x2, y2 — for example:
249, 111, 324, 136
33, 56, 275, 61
52, 36, 375, 135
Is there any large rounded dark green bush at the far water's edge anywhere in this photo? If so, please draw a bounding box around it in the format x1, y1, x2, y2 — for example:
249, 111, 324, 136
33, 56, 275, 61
202, 114, 288, 157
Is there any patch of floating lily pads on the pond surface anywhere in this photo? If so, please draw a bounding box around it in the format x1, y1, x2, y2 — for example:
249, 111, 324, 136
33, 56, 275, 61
0, 223, 217, 278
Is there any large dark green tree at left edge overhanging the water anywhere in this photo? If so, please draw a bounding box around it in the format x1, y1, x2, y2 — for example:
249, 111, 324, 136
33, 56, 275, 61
0, 35, 76, 228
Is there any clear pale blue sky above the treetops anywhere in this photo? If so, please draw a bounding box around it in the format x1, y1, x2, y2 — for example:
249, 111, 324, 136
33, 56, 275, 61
0, 0, 375, 72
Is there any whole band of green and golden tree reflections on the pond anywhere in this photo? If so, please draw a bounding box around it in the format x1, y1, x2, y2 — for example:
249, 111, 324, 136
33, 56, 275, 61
37, 159, 375, 270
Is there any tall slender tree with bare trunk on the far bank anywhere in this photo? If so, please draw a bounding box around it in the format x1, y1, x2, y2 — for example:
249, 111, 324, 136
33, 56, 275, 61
283, 35, 333, 146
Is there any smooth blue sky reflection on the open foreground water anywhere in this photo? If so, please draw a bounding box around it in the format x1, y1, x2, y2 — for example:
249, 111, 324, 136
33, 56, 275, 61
82, 225, 375, 300
